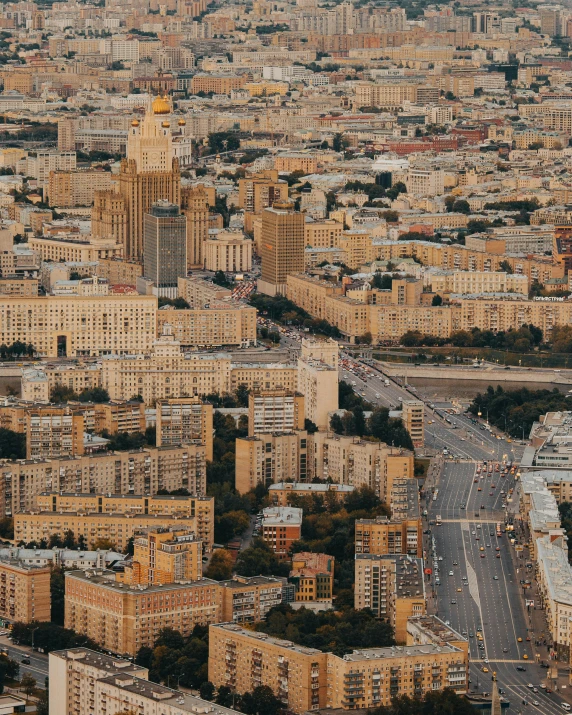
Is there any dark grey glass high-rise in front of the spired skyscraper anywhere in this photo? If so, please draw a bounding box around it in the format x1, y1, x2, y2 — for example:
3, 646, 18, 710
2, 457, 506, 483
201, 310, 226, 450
143, 201, 187, 298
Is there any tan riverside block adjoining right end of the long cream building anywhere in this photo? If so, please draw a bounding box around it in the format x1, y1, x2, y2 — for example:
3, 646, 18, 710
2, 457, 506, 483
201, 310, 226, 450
157, 303, 256, 348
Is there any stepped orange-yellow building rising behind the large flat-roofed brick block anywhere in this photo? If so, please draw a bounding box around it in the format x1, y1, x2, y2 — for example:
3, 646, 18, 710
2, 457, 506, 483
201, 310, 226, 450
123, 526, 203, 586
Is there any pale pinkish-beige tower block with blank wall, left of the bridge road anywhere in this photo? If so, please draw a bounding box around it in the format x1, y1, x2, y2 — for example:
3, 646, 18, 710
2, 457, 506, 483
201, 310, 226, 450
298, 357, 339, 430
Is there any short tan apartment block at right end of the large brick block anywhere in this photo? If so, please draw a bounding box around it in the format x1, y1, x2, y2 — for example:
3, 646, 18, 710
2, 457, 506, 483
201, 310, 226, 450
220, 576, 282, 623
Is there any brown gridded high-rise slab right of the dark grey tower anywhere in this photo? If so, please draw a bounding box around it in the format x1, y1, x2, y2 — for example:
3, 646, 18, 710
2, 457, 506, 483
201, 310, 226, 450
258, 201, 304, 295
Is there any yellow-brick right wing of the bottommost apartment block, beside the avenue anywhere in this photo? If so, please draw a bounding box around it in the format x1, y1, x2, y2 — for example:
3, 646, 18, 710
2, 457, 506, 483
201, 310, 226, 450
327, 644, 468, 710
